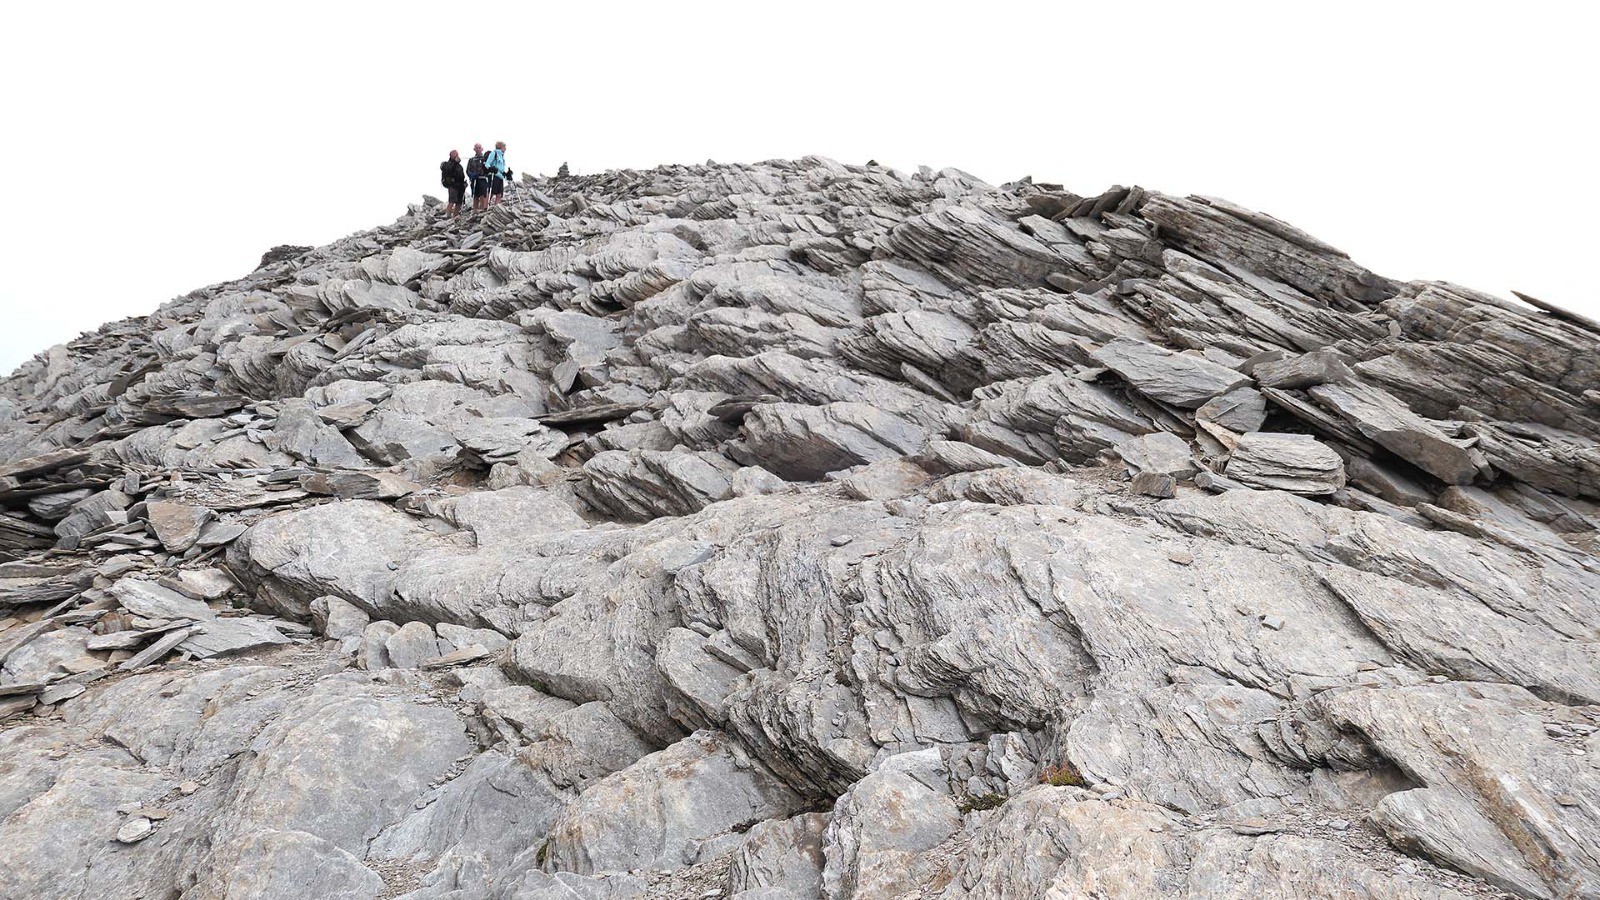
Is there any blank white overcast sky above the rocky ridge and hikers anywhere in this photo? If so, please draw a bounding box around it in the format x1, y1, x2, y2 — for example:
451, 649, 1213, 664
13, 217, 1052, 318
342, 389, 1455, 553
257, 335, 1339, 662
0, 0, 1600, 372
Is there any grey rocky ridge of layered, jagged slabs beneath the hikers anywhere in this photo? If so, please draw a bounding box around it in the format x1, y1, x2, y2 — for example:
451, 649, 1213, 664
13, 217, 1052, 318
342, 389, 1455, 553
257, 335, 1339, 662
0, 157, 1600, 900
